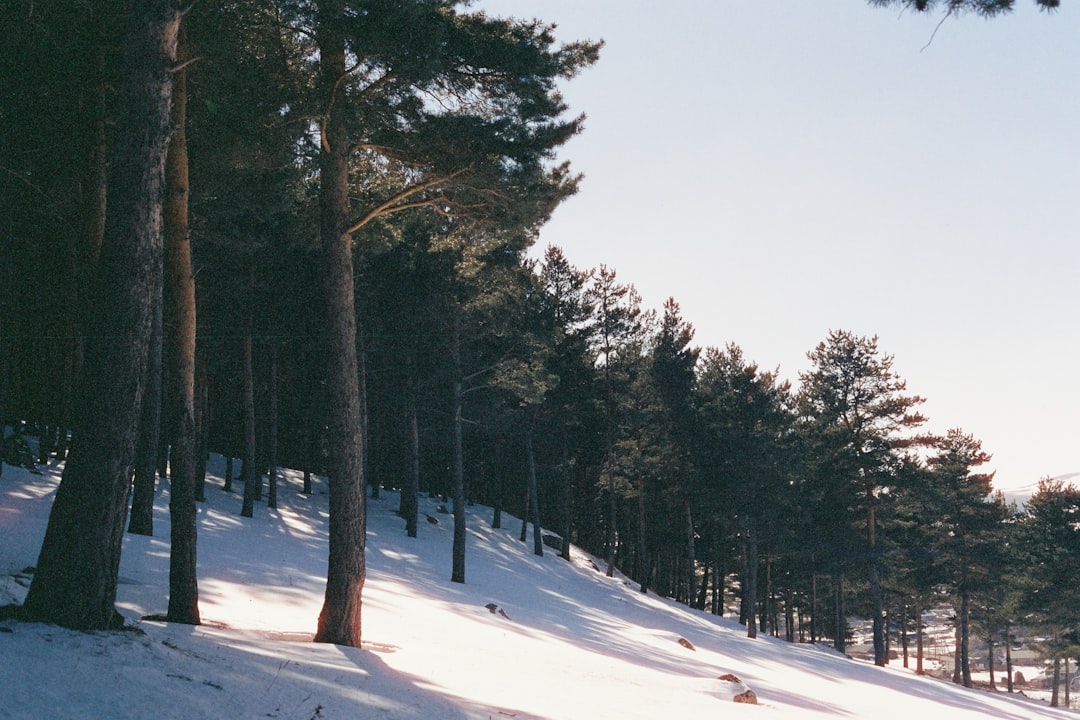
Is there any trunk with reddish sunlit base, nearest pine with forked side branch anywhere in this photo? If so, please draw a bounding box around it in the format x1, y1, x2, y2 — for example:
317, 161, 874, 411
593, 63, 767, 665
315, 0, 367, 648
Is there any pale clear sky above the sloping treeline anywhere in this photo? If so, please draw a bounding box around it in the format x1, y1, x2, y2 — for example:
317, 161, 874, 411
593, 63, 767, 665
474, 0, 1080, 489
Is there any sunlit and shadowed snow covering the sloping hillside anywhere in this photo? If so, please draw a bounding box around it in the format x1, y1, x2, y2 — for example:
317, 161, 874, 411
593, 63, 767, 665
0, 459, 1072, 720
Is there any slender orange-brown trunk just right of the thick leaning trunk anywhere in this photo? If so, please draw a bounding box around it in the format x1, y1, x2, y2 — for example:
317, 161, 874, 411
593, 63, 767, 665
164, 30, 199, 625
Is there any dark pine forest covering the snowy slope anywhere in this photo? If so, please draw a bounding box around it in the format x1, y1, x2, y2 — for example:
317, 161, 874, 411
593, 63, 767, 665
0, 0, 1080, 708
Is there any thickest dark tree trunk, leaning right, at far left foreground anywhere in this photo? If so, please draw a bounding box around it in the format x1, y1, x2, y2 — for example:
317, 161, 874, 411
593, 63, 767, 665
24, 0, 179, 629
